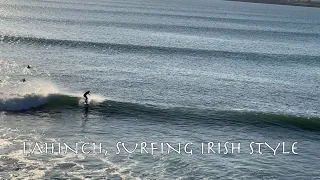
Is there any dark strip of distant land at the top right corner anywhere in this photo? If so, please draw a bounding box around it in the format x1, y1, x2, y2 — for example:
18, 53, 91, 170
227, 0, 320, 8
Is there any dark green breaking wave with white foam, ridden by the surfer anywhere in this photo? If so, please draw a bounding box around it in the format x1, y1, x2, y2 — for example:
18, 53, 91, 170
0, 86, 320, 131
